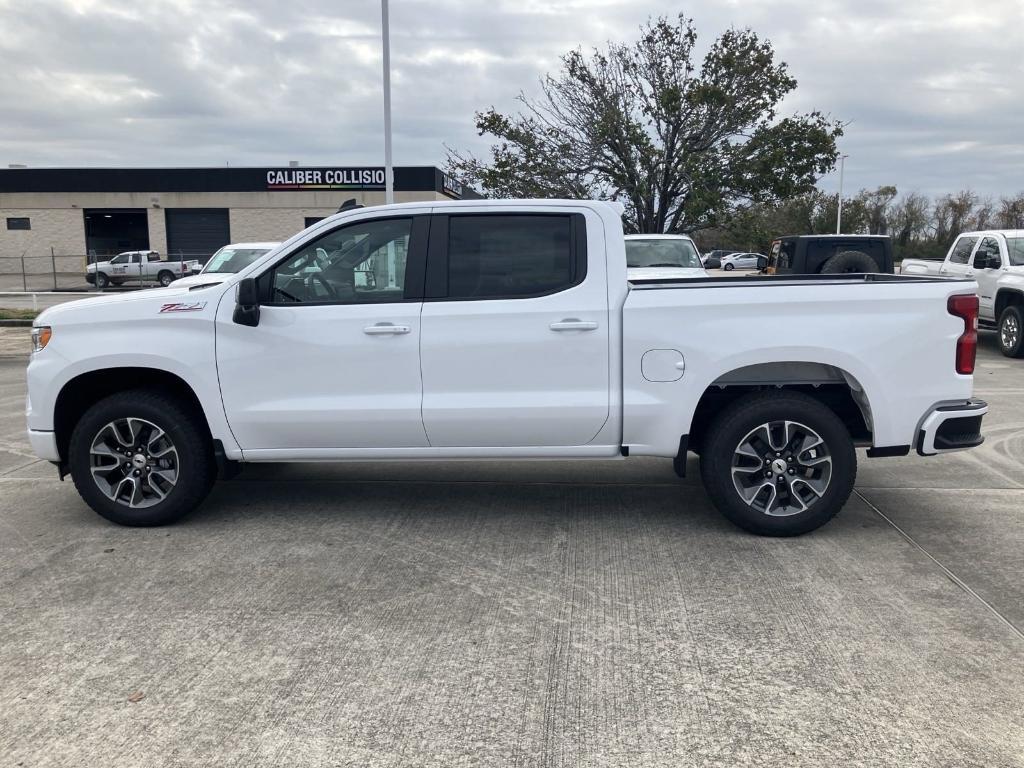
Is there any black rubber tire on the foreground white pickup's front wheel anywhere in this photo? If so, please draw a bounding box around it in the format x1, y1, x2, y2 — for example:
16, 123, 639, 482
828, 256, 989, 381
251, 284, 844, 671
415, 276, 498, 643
68, 389, 217, 526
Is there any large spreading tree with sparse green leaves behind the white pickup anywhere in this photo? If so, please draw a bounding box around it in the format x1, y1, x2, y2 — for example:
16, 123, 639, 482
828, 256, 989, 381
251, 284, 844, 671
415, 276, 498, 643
447, 15, 842, 232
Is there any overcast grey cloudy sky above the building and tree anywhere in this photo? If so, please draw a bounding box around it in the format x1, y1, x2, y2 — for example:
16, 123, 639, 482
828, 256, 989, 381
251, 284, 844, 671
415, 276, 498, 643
0, 0, 1024, 195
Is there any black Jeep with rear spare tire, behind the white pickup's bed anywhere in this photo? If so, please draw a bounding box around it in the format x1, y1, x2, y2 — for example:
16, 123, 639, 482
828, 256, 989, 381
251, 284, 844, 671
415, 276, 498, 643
765, 234, 893, 274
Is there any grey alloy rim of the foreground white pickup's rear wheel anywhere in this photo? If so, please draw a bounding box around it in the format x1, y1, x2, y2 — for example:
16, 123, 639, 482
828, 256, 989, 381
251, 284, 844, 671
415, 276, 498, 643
732, 421, 833, 517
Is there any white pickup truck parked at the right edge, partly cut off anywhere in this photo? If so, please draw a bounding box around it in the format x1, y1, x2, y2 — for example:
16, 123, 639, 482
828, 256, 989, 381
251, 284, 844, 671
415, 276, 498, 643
900, 229, 1024, 357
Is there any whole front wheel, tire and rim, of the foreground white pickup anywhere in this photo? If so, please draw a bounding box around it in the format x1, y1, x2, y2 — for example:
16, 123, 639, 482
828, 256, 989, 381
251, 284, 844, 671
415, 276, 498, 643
68, 389, 216, 525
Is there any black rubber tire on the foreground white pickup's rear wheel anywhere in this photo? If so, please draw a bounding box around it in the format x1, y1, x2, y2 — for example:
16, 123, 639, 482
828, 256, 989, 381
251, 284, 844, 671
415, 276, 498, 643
700, 392, 857, 537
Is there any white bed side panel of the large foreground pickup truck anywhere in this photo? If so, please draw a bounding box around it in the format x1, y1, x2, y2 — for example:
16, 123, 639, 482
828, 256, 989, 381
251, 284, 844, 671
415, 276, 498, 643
623, 274, 976, 455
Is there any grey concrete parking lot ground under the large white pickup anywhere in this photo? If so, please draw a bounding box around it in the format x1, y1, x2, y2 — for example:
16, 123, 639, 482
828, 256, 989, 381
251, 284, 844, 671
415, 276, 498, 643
0, 333, 1024, 767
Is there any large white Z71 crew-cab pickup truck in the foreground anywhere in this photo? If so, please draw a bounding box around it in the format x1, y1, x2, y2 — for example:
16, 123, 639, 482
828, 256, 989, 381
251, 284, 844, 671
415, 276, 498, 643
27, 200, 987, 536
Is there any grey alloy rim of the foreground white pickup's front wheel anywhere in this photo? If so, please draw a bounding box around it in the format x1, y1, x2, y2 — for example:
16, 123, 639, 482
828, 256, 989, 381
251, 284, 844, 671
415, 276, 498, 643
89, 417, 178, 509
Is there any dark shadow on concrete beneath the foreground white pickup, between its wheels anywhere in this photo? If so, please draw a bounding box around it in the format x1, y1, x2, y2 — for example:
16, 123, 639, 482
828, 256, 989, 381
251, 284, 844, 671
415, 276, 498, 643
195, 460, 731, 530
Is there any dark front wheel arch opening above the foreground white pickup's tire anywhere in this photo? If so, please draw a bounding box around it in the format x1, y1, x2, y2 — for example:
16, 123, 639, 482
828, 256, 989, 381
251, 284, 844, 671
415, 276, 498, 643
53, 367, 212, 462
